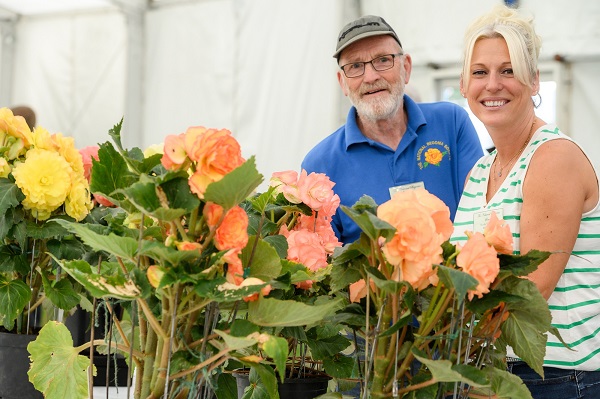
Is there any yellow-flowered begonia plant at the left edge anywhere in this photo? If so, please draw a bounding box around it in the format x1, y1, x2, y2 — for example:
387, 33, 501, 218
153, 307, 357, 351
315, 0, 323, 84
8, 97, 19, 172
0, 108, 92, 397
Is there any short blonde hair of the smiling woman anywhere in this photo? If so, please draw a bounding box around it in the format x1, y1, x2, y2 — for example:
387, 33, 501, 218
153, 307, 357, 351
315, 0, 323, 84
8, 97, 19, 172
462, 5, 542, 88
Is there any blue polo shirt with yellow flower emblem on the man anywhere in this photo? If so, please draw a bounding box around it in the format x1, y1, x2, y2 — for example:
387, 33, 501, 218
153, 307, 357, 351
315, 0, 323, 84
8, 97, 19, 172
302, 95, 483, 244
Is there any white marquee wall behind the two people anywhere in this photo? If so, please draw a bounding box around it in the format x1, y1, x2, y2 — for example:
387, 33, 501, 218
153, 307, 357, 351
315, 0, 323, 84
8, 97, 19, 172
0, 0, 600, 191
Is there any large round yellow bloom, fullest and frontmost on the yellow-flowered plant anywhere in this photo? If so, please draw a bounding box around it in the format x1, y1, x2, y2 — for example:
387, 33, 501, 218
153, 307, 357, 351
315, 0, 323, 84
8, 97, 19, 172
12, 149, 71, 220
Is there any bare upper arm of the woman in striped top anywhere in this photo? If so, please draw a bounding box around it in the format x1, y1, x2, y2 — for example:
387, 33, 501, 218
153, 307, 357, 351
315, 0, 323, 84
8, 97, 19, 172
520, 140, 598, 299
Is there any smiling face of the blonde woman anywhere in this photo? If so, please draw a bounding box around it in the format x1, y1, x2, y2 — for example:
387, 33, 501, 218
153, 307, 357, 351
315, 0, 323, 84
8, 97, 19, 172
461, 38, 537, 128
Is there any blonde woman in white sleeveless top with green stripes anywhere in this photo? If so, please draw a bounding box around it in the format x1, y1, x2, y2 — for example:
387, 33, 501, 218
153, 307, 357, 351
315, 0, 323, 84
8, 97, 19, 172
452, 6, 600, 399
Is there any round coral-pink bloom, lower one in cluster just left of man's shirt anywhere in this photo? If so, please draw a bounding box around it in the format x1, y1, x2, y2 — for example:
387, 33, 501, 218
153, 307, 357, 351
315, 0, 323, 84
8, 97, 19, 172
287, 230, 327, 272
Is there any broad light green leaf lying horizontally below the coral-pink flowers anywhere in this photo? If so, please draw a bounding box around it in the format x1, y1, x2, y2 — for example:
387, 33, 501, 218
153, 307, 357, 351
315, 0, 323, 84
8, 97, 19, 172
248, 297, 343, 327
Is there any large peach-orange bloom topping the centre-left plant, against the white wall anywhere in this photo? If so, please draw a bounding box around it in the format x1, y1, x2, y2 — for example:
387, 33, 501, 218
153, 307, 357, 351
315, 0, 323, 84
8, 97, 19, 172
185, 127, 244, 199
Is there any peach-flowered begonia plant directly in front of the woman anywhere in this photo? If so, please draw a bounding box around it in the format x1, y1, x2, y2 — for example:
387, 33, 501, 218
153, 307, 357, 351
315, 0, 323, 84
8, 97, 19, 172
332, 189, 558, 398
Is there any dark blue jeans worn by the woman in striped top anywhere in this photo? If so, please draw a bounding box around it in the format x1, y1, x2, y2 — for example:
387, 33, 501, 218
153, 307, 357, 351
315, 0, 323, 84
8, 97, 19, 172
508, 362, 600, 399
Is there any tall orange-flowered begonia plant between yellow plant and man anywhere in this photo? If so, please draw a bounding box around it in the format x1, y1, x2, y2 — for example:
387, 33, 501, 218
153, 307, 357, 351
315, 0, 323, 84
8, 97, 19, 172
28, 123, 354, 399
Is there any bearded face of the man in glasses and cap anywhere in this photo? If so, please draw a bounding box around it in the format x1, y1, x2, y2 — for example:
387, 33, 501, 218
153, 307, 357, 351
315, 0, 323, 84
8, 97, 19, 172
338, 35, 411, 121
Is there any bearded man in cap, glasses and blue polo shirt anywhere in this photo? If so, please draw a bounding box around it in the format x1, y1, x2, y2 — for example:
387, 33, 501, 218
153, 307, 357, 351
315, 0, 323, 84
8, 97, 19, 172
302, 15, 483, 243
